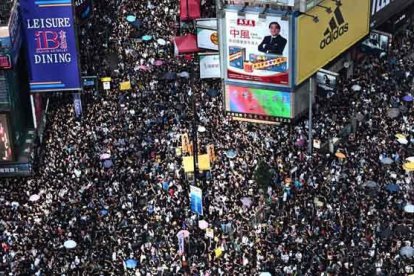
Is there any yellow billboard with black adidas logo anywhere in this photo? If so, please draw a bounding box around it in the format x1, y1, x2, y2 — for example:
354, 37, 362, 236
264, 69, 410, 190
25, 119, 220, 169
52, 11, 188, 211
296, 0, 371, 84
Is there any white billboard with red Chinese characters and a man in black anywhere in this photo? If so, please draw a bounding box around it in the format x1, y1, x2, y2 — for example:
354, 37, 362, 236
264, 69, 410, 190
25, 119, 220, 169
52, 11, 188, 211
224, 10, 289, 86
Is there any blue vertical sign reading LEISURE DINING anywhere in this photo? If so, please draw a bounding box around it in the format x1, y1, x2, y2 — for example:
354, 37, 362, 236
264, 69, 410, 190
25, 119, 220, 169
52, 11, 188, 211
20, 0, 82, 92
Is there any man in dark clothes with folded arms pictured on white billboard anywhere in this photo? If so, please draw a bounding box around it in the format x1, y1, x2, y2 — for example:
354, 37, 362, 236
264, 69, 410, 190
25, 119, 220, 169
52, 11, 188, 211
258, 22, 287, 55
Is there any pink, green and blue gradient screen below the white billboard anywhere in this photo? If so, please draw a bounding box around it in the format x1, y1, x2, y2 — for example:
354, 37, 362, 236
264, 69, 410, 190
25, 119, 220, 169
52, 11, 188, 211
226, 85, 291, 118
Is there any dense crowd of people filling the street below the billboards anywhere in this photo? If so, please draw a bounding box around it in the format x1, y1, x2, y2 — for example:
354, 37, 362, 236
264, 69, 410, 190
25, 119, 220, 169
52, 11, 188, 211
0, 0, 414, 275
